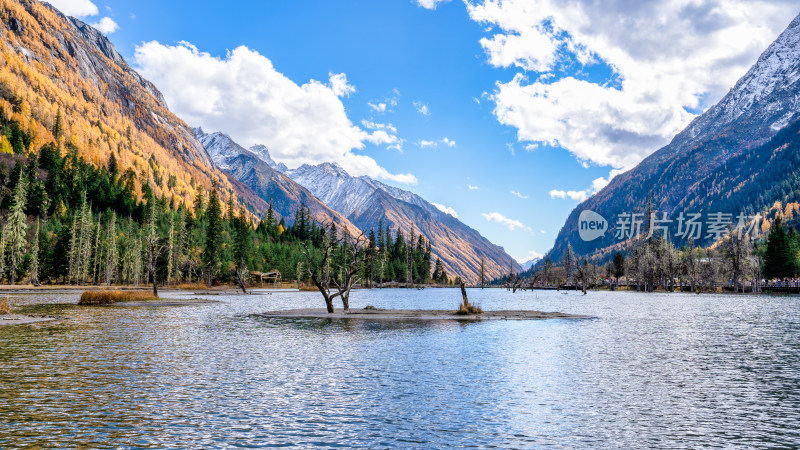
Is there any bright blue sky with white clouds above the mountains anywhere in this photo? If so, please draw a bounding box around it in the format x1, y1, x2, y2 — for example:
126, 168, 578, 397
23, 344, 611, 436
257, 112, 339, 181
48, 0, 800, 260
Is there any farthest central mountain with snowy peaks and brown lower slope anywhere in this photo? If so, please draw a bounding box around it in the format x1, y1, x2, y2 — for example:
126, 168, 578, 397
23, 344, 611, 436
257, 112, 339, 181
286, 163, 521, 282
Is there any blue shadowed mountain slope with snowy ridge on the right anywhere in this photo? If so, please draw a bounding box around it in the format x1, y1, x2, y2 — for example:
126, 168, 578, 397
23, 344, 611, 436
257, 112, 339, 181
549, 12, 800, 260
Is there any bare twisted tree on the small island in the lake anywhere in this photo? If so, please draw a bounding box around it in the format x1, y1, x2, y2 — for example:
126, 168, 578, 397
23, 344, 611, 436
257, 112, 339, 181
302, 223, 368, 314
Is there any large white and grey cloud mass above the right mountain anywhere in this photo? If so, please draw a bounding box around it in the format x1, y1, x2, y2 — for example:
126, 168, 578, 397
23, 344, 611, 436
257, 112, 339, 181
467, 0, 798, 168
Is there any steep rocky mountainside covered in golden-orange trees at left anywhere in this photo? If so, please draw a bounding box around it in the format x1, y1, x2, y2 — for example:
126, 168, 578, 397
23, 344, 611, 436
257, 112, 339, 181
0, 0, 266, 211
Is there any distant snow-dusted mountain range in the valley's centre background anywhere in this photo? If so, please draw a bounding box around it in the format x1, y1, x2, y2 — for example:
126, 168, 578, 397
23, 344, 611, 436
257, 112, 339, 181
195, 129, 522, 282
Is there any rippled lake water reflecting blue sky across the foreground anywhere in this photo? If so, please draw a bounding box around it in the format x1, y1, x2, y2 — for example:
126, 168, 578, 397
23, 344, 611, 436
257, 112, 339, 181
0, 289, 800, 448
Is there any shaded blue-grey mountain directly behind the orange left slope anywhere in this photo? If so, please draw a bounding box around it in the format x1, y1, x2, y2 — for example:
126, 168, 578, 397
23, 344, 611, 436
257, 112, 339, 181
193, 128, 357, 230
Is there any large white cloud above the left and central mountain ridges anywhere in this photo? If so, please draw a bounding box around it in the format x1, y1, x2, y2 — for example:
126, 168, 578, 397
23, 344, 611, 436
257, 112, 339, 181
135, 41, 416, 183
